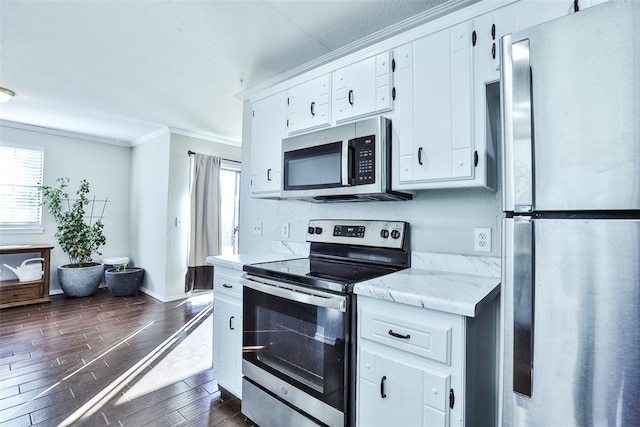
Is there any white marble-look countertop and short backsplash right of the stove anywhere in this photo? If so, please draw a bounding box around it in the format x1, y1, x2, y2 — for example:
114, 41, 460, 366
354, 253, 500, 317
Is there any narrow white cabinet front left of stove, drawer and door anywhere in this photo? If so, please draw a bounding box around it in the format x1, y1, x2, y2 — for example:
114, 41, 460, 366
213, 266, 242, 398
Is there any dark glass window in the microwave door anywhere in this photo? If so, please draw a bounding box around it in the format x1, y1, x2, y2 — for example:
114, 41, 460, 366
284, 141, 342, 190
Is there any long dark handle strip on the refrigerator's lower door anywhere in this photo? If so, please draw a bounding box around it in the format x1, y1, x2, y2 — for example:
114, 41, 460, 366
513, 217, 535, 397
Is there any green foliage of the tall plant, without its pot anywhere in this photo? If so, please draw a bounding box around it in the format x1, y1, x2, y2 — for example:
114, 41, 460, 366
38, 178, 108, 267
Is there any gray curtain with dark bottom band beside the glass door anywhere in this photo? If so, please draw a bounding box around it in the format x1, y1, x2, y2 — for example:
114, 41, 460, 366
185, 153, 222, 292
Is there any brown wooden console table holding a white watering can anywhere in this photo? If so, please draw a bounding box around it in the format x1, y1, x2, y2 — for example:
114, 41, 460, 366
0, 245, 53, 309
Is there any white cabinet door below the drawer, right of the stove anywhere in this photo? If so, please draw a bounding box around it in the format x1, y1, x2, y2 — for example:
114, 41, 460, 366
357, 348, 450, 427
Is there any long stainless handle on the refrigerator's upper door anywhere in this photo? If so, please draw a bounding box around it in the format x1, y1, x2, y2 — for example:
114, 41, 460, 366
501, 35, 534, 213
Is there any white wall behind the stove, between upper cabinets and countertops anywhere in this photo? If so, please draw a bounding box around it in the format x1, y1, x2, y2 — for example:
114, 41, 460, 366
240, 101, 502, 256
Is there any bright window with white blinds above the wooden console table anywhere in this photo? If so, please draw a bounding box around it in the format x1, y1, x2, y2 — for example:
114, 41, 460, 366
0, 145, 44, 231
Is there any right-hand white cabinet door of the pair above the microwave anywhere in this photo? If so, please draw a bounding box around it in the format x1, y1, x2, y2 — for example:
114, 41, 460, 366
332, 51, 393, 123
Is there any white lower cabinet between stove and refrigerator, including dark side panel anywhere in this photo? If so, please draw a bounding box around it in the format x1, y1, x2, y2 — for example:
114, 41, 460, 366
356, 296, 498, 427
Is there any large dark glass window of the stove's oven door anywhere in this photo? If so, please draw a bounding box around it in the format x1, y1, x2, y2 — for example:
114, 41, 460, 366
243, 287, 348, 411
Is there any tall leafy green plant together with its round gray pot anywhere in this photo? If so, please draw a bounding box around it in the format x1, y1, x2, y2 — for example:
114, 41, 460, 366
39, 178, 107, 297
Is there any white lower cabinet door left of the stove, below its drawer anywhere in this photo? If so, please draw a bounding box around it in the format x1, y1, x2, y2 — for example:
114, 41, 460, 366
213, 296, 242, 397
